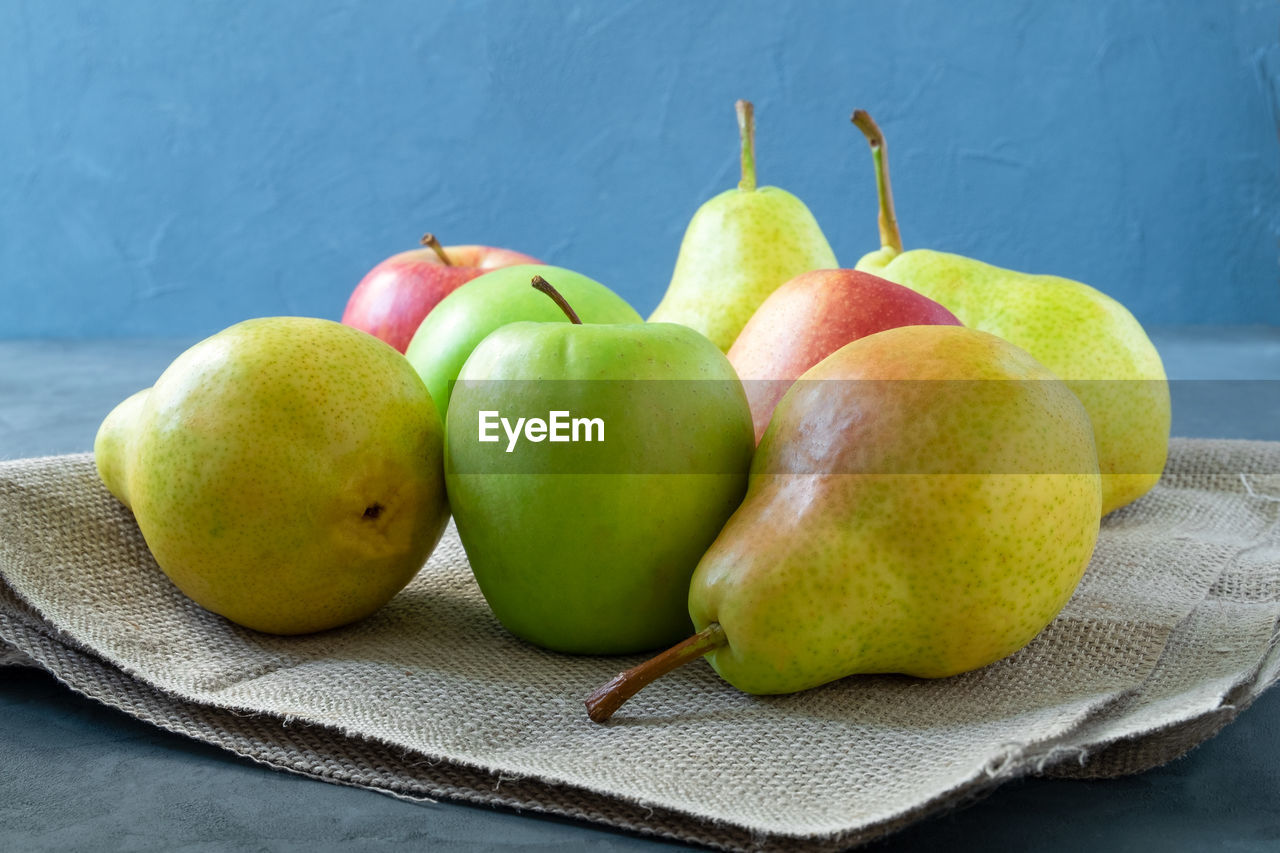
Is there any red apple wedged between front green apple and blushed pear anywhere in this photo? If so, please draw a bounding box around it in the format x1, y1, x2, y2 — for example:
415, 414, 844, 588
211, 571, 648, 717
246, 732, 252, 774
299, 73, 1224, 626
728, 269, 961, 442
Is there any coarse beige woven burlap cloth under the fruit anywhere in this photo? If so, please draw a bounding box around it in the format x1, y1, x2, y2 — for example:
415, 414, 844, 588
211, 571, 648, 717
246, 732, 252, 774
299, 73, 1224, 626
0, 439, 1280, 849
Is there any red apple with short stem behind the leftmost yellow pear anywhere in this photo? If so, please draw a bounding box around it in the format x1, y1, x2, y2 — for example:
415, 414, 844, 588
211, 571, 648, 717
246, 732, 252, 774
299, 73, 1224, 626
342, 234, 541, 352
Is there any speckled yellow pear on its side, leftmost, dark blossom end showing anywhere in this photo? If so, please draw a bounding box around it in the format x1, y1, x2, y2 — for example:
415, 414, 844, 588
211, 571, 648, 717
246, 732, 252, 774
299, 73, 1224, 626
95, 318, 448, 634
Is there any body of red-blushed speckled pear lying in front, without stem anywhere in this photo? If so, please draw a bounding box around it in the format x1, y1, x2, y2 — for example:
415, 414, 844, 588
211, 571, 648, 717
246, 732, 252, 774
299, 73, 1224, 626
689, 325, 1101, 693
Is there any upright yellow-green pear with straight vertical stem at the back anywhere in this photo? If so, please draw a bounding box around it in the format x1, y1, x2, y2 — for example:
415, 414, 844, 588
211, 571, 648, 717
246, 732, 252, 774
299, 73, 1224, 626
649, 101, 837, 352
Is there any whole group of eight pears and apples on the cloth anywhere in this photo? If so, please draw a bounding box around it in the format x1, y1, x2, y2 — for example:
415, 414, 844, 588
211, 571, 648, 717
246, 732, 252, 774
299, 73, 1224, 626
93, 101, 1170, 721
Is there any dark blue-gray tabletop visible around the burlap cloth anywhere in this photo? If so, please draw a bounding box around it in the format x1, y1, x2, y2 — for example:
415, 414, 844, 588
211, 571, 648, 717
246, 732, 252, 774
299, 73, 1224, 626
0, 327, 1280, 853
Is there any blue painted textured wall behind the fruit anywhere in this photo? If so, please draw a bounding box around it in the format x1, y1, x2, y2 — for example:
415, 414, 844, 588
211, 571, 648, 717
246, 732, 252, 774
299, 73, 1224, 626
0, 0, 1280, 337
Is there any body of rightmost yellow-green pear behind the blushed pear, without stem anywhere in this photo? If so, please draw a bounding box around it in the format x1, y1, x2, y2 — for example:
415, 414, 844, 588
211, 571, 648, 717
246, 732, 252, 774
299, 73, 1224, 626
858, 248, 1170, 514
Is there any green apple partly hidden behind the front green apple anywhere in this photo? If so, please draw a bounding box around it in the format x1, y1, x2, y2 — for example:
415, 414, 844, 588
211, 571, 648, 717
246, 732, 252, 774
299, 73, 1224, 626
404, 258, 641, 420
